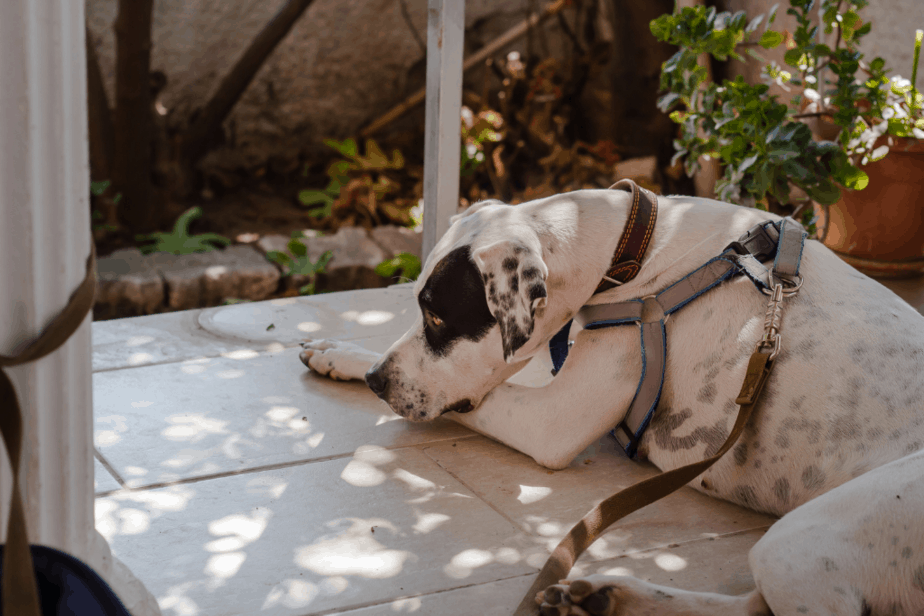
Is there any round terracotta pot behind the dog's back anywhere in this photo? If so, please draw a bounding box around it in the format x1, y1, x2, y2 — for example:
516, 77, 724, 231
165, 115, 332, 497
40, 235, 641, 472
815, 137, 924, 277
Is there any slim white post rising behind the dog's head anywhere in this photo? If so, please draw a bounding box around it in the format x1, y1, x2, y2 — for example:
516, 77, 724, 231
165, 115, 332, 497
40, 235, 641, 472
423, 0, 465, 259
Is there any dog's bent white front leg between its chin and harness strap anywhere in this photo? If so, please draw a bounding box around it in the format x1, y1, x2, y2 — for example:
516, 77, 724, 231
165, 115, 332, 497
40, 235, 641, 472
447, 327, 641, 468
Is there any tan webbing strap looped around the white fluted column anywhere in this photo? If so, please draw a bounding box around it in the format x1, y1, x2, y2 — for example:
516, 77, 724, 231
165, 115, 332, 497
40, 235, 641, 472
0, 241, 96, 616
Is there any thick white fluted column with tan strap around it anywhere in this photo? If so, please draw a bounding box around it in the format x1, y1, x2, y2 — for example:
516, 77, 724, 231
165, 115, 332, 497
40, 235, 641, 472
0, 0, 160, 616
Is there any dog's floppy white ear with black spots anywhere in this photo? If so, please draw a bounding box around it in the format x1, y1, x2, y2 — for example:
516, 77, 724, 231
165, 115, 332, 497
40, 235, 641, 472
472, 240, 549, 363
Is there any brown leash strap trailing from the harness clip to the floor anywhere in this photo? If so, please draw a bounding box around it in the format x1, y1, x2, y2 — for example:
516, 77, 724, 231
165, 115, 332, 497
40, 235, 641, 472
514, 350, 773, 616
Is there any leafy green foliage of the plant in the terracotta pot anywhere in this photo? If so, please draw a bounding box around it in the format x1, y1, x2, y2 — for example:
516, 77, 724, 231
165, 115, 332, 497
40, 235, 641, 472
651, 0, 921, 274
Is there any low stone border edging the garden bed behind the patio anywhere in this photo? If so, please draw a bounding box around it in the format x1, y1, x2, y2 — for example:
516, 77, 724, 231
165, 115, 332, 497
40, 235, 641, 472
93, 226, 421, 320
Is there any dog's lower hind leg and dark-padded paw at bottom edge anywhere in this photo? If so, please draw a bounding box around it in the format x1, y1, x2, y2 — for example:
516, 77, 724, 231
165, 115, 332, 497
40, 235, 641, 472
536, 575, 772, 616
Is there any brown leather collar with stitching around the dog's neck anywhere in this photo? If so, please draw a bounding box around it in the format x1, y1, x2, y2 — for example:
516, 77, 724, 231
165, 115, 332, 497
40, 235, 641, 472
594, 180, 658, 294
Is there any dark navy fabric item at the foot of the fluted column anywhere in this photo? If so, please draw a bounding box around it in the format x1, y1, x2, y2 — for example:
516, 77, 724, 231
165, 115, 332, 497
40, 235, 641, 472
0, 545, 131, 616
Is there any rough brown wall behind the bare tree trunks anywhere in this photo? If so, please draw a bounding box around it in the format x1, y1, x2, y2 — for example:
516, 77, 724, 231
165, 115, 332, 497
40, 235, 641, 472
86, 0, 561, 174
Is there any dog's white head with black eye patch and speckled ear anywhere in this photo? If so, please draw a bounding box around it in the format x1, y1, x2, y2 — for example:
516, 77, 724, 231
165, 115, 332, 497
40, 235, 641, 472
366, 202, 549, 421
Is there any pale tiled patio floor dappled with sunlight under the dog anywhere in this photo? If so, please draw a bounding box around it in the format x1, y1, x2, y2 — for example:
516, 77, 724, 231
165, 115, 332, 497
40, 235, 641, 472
93, 280, 924, 616
